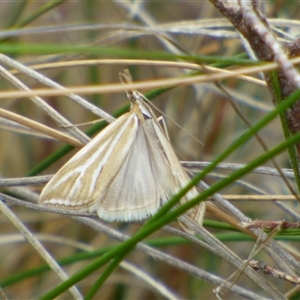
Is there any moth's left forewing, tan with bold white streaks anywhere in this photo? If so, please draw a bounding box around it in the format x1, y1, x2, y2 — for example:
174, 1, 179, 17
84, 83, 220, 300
39, 113, 134, 211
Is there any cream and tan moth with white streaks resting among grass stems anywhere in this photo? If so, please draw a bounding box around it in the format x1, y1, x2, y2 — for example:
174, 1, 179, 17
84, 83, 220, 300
39, 70, 205, 223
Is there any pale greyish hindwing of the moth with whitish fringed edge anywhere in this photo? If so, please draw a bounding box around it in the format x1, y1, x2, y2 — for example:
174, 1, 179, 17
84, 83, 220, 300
97, 113, 175, 221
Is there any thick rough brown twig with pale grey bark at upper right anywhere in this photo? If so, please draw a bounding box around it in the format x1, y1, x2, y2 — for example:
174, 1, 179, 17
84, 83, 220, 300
210, 0, 300, 155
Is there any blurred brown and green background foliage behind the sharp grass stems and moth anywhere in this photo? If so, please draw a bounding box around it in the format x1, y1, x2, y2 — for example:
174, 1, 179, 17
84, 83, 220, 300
0, 1, 300, 299
